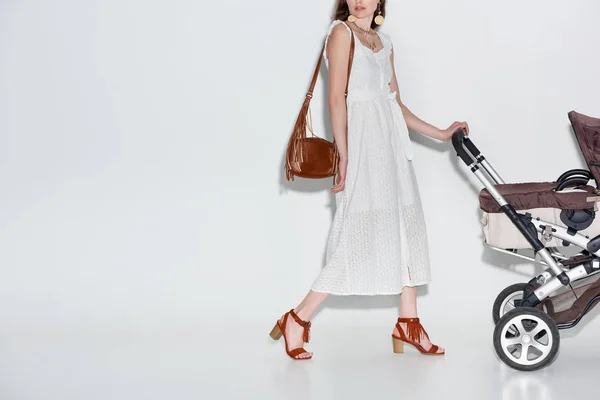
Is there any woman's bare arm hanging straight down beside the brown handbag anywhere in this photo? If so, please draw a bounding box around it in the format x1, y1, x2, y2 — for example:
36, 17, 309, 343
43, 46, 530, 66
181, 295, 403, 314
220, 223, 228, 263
325, 24, 350, 161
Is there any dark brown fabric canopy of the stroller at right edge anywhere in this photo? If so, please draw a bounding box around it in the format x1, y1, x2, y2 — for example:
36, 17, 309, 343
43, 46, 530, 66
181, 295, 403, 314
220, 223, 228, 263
569, 111, 600, 184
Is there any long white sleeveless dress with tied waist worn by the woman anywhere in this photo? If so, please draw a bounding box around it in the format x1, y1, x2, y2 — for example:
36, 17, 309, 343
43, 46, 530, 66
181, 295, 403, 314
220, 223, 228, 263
312, 20, 430, 295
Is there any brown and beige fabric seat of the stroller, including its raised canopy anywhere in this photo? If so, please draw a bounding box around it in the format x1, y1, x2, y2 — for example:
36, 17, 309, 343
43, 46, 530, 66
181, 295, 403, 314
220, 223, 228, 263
479, 111, 600, 249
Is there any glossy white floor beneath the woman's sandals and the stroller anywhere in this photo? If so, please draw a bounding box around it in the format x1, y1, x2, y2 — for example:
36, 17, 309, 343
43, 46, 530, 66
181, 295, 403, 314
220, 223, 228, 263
0, 321, 600, 400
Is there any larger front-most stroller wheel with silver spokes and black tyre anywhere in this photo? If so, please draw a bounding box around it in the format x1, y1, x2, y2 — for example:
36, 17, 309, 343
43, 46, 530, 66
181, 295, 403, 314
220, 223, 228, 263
494, 307, 560, 371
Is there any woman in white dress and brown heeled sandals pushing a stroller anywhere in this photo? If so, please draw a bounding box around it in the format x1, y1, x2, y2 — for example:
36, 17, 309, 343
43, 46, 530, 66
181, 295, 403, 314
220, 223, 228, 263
271, 0, 468, 360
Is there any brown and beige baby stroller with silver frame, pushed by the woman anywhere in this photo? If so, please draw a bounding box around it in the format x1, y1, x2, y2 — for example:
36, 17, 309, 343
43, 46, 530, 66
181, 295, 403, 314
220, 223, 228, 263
452, 111, 600, 371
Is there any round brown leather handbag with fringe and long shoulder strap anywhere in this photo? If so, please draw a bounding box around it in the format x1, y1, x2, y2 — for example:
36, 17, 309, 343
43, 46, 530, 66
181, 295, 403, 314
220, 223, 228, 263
285, 22, 354, 183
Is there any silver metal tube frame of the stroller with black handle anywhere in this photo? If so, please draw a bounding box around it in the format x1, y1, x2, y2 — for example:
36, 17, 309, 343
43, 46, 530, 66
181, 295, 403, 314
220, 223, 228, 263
452, 129, 600, 318
